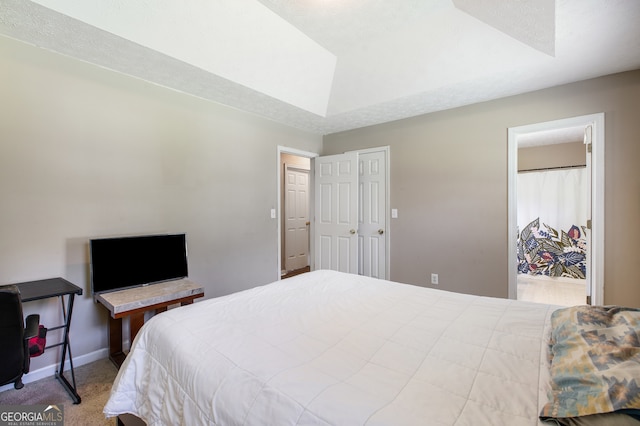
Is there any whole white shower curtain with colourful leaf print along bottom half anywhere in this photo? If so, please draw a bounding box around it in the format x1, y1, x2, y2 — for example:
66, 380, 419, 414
518, 168, 589, 278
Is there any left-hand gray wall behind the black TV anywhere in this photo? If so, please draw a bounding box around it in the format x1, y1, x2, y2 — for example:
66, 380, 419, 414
0, 38, 322, 370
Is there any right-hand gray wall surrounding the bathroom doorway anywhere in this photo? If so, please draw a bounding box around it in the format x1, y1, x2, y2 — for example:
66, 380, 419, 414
324, 71, 640, 307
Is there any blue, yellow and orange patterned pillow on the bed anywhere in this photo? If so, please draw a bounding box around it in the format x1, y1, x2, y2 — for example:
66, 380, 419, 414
540, 306, 640, 420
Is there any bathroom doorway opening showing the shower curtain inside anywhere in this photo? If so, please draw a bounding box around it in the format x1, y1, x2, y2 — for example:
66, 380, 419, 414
517, 131, 591, 306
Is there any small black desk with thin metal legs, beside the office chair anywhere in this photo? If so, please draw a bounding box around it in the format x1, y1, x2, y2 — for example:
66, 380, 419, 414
16, 278, 82, 404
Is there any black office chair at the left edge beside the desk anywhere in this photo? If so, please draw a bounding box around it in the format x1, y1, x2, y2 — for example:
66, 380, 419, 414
0, 285, 40, 389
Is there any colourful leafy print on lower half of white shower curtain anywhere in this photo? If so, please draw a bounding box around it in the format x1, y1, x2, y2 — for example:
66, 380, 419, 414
518, 218, 587, 278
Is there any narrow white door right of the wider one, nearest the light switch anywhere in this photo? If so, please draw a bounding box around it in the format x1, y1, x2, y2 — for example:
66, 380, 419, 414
358, 151, 387, 279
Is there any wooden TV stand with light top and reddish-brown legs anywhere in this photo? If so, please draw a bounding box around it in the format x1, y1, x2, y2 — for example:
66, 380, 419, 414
94, 279, 204, 368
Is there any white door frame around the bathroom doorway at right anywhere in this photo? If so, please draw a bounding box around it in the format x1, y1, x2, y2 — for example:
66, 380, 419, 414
507, 113, 605, 305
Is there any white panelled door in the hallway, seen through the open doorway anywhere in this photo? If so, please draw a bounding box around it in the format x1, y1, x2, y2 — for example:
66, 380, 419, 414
284, 165, 309, 271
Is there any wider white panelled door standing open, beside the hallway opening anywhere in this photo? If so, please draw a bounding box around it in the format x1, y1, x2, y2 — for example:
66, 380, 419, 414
314, 152, 358, 274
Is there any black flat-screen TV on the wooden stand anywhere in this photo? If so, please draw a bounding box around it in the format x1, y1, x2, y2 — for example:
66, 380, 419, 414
89, 234, 188, 294
